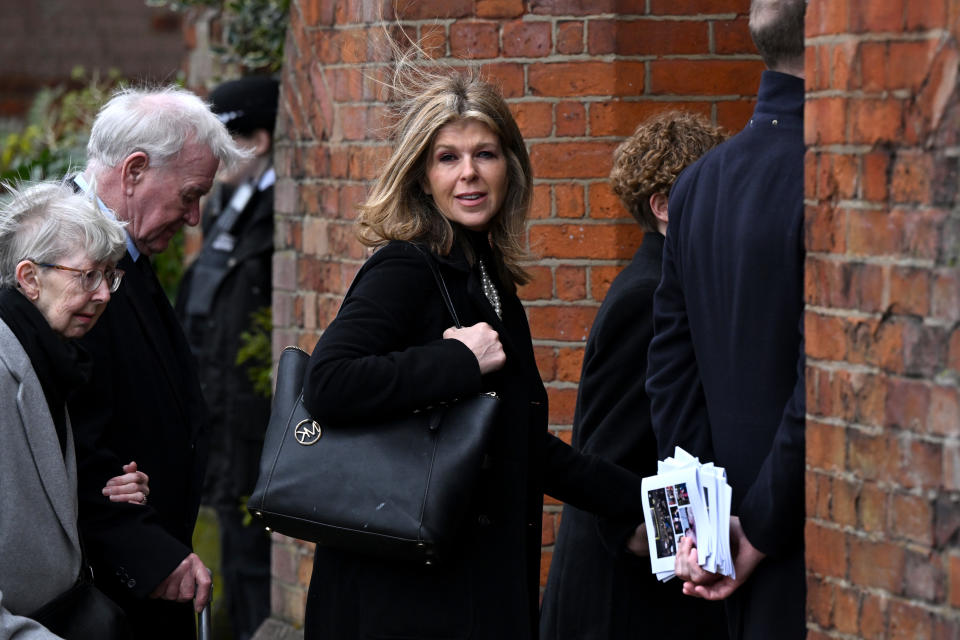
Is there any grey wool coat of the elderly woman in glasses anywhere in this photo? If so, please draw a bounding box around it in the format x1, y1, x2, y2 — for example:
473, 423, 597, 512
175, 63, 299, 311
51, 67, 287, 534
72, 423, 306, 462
0, 320, 81, 640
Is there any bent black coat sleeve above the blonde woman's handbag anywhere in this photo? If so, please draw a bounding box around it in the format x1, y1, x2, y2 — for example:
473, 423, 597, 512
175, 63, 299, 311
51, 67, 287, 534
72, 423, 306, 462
304, 247, 481, 422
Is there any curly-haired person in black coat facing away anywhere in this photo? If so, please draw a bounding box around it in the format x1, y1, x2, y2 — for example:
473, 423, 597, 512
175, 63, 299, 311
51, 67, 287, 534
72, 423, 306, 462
540, 111, 726, 640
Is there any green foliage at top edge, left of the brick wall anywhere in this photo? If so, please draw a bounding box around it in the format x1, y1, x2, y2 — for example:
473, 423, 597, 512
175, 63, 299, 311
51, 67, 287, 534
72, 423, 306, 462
146, 0, 290, 72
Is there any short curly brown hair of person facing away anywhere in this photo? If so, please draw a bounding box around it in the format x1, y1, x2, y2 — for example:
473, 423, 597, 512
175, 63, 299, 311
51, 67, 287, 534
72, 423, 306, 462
610, 111, 727, 231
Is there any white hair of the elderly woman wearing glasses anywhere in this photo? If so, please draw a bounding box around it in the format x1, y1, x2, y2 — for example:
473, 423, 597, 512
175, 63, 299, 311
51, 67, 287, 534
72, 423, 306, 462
0, 182, 127, 287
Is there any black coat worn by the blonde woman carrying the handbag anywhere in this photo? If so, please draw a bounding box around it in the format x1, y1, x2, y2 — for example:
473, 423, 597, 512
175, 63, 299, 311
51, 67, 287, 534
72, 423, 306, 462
304, 238, 642, 640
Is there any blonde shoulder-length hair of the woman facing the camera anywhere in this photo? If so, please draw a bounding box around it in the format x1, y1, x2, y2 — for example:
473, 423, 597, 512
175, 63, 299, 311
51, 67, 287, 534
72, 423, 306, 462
357, 57, 533, 286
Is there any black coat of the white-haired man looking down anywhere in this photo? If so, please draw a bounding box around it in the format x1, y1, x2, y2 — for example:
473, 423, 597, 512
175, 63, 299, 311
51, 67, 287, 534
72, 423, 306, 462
69, 254, 207, 639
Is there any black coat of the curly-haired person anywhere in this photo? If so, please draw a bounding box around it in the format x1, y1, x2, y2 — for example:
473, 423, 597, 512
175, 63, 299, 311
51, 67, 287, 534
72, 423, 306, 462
540, 232, 726, 640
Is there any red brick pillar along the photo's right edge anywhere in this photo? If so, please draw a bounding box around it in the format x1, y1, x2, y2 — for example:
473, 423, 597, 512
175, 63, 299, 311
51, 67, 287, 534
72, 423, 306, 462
806, 0, 960, 640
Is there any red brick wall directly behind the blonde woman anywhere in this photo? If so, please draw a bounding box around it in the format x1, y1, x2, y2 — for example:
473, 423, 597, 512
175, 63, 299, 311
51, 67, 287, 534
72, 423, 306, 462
273, 0, 763, 624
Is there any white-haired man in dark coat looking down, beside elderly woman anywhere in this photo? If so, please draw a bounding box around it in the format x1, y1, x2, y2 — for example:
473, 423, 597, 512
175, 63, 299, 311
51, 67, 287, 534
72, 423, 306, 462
69, 88, 245, 640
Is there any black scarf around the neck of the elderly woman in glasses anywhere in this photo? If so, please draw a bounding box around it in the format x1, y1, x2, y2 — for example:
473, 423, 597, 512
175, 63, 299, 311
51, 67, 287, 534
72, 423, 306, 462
0, 287, 93, 454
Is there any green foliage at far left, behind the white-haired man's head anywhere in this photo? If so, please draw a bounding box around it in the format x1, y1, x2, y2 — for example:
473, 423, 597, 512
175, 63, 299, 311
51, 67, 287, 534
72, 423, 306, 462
0, 67, 121, 182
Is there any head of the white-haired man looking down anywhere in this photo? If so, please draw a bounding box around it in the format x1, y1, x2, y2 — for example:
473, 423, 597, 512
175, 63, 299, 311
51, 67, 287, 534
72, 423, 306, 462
85, 87, 247, 255
